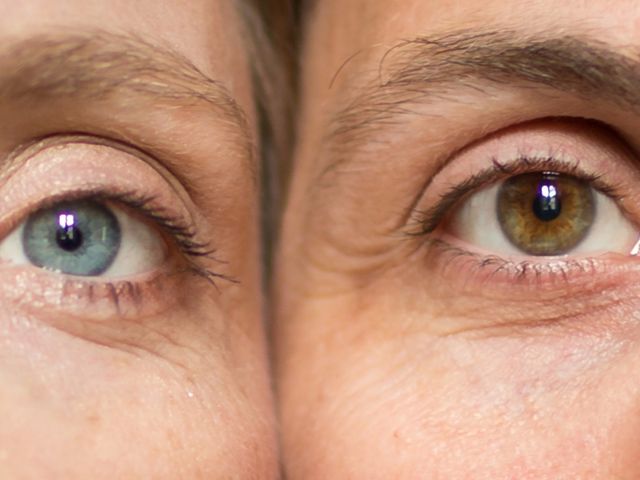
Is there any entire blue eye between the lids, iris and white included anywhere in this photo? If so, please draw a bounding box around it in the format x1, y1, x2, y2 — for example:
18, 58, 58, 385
0, 199, 168, 278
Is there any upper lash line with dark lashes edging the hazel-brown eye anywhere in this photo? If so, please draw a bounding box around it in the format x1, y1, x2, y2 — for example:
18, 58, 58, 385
405, 156, 624, 236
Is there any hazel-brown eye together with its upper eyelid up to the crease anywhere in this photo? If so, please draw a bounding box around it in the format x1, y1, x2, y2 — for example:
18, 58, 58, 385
409, 117, 640, 265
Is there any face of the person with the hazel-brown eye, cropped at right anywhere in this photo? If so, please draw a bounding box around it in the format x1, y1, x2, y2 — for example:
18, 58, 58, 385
276, 0, 640, 480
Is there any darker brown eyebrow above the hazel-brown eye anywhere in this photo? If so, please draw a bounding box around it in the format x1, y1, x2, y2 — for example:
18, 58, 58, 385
328, 31, 640, 147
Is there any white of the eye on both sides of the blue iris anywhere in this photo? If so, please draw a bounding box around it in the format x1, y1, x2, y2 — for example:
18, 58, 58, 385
0, 207, 167, 277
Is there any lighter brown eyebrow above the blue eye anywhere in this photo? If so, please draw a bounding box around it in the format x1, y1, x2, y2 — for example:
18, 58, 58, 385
0, 31, 249, 132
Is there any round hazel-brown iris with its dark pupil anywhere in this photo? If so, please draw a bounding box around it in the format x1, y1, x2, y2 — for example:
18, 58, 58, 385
498, 172, 595, 256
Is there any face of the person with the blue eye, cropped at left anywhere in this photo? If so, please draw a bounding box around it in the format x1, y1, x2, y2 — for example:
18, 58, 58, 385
0, 0, 277, 479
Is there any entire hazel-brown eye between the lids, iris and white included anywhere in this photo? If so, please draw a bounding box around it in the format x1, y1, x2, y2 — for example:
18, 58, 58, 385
448, 172, 638, 257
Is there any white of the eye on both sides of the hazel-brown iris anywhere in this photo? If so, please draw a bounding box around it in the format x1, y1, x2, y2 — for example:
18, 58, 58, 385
452, 184, 638, 256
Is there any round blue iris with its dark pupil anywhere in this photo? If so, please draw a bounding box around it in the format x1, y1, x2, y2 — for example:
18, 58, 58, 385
22, 201, 121, 276
